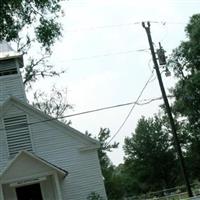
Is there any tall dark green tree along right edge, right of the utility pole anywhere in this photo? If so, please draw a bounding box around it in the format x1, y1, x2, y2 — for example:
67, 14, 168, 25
169, 14, 200, 179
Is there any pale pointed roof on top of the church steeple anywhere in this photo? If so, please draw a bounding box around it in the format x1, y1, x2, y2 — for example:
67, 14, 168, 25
0, 41, 21, 60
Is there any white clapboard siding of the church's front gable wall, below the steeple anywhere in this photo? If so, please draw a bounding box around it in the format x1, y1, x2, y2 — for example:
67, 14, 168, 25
0, 104, 106, 200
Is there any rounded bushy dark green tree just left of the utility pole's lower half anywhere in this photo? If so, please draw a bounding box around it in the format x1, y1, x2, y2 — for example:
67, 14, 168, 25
124, 116, 177, 195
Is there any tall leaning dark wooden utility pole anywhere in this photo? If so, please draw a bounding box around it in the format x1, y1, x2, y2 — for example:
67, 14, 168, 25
142, 22, 193, 197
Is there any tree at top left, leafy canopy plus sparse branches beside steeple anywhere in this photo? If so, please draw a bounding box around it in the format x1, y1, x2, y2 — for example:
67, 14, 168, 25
0, 0, 62, 86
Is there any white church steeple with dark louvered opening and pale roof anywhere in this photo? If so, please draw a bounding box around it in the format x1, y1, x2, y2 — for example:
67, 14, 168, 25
0, 41, 27, 103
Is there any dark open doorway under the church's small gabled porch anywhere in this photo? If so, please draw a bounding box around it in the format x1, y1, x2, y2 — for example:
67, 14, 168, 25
16, 183, 43, 200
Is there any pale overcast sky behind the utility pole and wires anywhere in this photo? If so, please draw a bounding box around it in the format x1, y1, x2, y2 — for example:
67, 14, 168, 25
28, 0, 200, 165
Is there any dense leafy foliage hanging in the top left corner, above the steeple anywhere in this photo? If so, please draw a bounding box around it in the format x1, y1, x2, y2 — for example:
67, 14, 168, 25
0, 0, 61, 50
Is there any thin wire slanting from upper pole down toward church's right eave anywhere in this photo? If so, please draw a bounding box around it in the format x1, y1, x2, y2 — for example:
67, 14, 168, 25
107, 70, 154, 145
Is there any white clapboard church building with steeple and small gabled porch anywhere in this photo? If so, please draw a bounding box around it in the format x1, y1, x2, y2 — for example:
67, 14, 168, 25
0, 42, 107, 200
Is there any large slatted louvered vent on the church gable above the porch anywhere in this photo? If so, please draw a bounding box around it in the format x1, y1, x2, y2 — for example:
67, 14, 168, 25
4, 115, 32, 156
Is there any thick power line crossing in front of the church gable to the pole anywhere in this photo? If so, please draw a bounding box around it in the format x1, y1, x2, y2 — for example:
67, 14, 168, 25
0, 96, 173, 131
